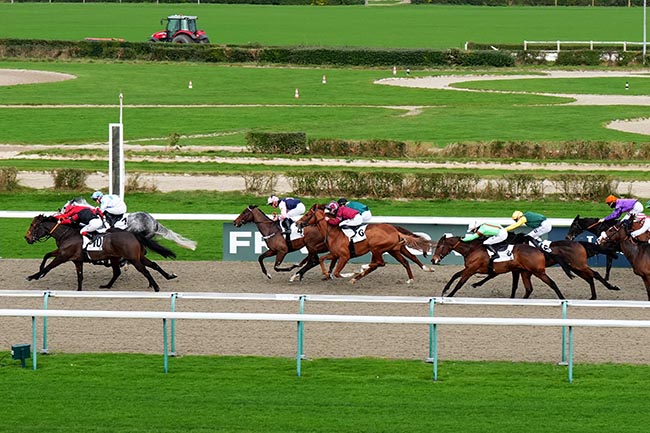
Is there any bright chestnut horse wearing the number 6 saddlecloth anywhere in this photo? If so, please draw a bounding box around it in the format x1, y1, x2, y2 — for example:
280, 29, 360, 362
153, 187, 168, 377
297, 204, 433, 284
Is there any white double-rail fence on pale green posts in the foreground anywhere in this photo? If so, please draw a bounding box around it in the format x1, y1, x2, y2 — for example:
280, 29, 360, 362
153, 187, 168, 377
0, 290, 650, 383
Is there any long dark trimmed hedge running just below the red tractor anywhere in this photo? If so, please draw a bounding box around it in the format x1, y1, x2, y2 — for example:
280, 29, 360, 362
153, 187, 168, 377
0, 39, 514, 67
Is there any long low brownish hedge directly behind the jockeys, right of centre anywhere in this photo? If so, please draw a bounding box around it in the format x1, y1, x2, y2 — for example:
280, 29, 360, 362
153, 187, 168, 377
288, 171, 618, 200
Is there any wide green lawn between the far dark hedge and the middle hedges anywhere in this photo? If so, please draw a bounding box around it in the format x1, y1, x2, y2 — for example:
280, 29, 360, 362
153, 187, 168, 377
0, 62, 647, 145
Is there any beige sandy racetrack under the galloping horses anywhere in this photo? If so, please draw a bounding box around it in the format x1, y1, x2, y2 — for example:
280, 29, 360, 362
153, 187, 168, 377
0, 259, 650, 364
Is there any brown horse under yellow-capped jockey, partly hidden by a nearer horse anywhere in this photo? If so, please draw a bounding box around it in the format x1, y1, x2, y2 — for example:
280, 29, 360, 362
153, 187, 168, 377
472, 233, 620, 300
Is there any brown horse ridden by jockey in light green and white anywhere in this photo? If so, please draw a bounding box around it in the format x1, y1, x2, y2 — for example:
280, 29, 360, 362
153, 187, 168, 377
431, 236, 572, 299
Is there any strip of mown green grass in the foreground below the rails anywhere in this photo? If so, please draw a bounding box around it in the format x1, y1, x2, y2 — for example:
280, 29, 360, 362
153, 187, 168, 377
0, 352, 650, 433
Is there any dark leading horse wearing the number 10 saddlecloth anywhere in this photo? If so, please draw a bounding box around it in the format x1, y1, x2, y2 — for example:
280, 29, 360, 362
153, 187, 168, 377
25, 215, 176, 292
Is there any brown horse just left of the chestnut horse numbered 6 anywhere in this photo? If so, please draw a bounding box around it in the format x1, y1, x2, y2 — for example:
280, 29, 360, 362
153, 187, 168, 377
233, 205, 327, 281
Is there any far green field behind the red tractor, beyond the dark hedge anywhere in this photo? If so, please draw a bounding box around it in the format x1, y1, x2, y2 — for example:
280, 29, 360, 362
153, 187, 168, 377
0, 2, 643, 49
